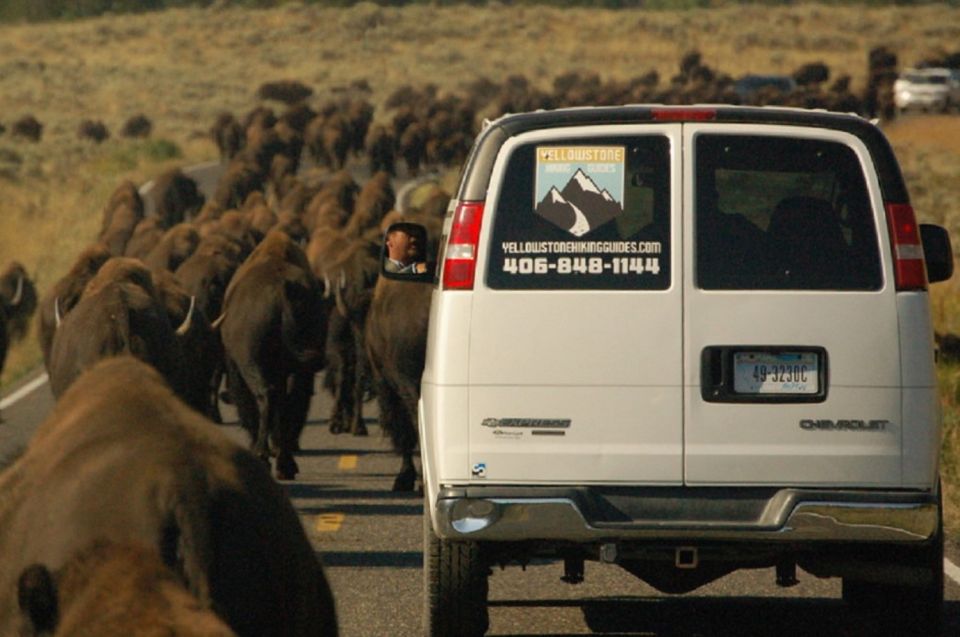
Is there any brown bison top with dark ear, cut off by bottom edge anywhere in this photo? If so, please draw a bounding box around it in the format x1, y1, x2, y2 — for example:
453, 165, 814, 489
17, 540, 236, 637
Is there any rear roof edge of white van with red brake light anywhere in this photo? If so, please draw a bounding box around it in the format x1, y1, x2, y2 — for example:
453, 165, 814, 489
457, 104, 909, 203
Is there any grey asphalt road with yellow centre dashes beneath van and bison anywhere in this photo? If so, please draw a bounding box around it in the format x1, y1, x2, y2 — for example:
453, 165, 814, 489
0, 370, 960, 637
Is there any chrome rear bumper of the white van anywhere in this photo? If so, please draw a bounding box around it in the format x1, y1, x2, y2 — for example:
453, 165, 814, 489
433, 486, 940, 543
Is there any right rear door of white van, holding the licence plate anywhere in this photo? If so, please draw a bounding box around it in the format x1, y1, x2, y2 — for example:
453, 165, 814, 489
683, 123, 902, 486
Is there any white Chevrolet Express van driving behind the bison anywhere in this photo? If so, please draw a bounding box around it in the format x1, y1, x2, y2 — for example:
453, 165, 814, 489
382, 106, 953, 636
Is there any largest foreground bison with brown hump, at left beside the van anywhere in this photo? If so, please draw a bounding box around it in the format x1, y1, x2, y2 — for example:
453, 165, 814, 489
0, 356, 337, 637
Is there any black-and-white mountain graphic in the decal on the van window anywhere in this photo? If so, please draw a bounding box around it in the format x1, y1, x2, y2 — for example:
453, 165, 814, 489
536, 169, 623, 237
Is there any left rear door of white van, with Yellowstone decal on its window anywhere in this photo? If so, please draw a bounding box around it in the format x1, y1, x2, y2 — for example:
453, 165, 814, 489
464, 124, 683, 484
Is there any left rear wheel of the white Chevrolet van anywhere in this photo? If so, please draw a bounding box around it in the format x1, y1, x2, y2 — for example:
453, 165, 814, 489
423, 512, 490, 637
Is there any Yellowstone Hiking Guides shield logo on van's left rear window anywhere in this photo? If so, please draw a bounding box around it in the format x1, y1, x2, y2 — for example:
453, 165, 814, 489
534, 146, 626, 237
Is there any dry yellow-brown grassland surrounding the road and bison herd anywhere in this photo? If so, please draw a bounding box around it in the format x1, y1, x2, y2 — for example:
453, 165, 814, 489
0, 3, 960, 532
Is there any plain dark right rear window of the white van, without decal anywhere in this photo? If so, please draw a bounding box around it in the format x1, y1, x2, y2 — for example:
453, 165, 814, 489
694, 135, 883, 290
